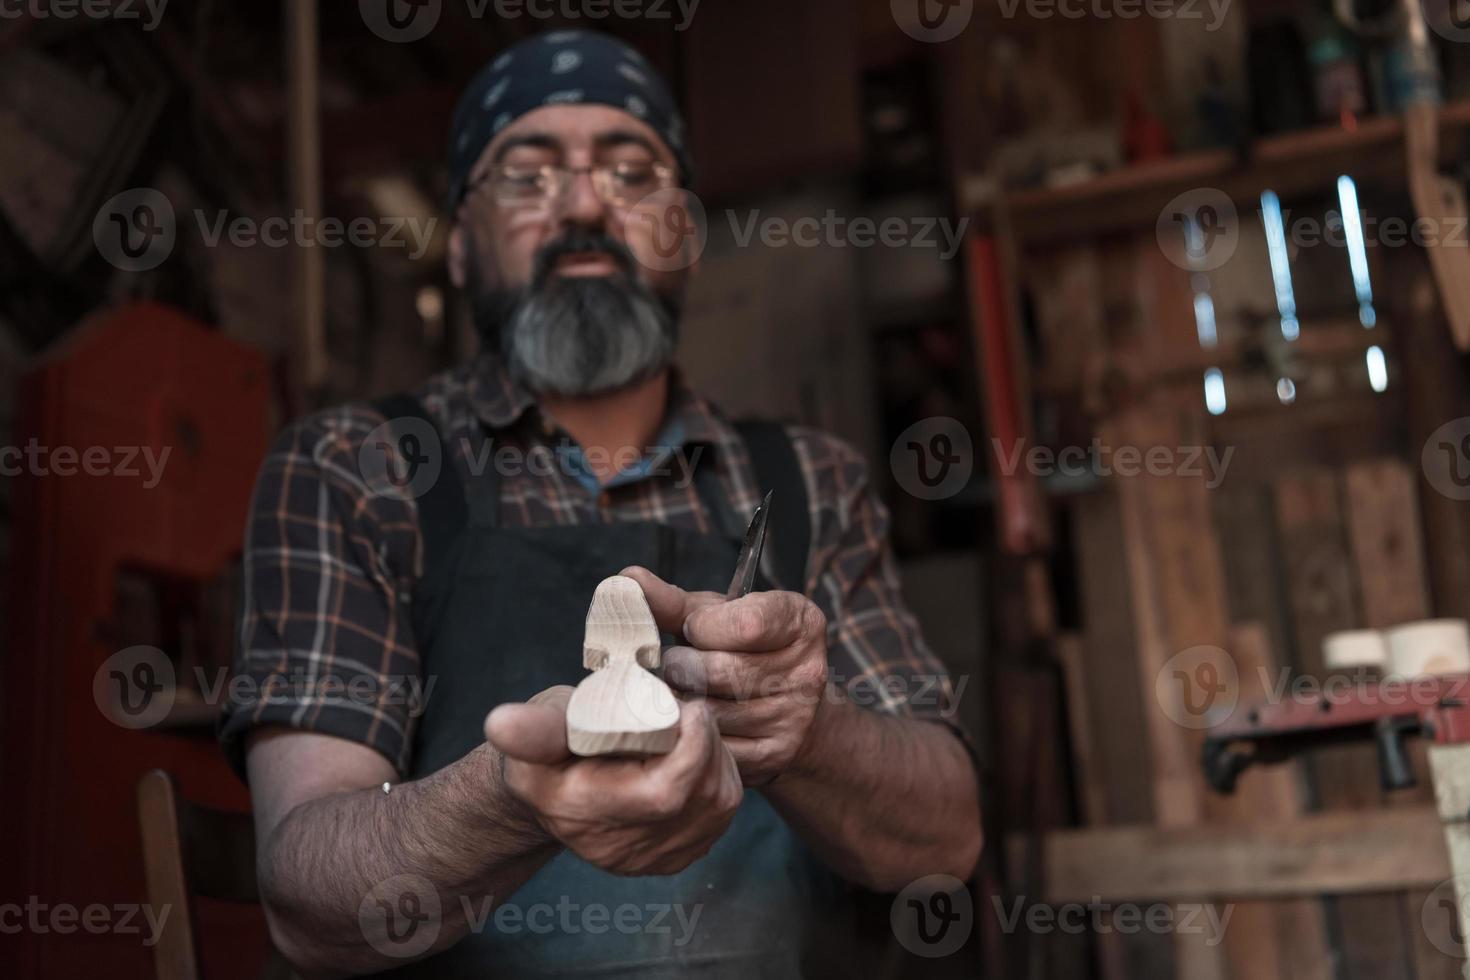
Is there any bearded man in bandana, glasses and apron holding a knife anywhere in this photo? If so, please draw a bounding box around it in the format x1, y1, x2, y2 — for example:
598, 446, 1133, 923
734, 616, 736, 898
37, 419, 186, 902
222, 31, 980, 977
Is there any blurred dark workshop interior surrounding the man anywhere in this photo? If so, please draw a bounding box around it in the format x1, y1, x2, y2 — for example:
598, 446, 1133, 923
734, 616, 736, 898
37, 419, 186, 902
14, 0, 1470, 980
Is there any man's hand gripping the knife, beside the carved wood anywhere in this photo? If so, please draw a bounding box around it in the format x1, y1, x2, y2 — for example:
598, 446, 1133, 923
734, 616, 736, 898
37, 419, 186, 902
622, 567, 828, 786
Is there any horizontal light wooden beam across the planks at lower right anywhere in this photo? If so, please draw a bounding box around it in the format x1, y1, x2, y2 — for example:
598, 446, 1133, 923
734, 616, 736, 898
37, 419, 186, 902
1005, 811, 1449, 905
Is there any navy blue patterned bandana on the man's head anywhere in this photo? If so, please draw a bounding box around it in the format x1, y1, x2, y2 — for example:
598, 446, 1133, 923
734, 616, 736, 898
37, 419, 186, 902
448, 31, 691, 213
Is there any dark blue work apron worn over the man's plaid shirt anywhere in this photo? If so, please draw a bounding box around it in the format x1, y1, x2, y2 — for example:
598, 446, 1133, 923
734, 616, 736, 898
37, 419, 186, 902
390, 399, 853, 979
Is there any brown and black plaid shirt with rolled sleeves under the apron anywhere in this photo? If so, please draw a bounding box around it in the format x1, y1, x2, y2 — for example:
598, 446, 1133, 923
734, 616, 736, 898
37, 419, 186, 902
221, 357, 963, 773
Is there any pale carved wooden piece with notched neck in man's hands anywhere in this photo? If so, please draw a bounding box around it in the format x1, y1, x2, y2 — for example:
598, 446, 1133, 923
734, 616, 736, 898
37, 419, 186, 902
566, 574, 679, 755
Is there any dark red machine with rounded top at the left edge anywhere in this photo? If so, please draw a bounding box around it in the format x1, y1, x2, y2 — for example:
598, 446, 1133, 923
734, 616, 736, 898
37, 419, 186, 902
0, 304, 269, 979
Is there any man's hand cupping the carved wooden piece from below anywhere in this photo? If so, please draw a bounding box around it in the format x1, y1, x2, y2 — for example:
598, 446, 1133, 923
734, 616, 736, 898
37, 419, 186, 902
485, 686, 744, 874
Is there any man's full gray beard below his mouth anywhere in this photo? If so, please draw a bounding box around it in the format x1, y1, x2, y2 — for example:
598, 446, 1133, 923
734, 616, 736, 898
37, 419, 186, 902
472, 252, 682, 397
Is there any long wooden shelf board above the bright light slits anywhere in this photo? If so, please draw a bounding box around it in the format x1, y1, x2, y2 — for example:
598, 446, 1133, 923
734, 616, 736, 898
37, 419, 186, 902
961, 100, 1470, 245
